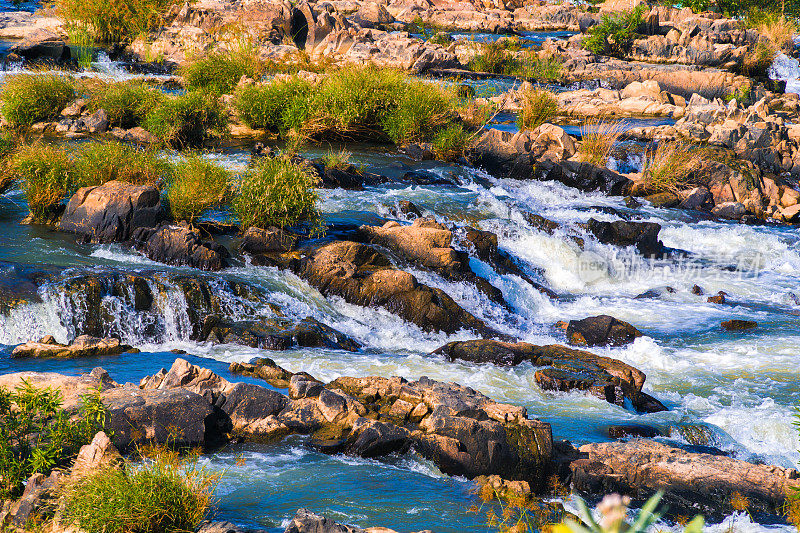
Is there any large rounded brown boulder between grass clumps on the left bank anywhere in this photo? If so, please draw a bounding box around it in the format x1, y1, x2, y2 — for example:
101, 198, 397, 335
58, 181, 166, 242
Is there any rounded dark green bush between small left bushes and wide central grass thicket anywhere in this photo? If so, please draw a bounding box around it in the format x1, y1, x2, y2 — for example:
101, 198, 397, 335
142, 91, 228, 148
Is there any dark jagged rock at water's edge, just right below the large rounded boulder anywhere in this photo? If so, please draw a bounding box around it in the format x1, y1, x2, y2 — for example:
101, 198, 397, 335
131, 222, 229, 270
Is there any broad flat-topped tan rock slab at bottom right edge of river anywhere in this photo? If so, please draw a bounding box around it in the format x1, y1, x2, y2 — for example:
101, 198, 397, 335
570, 439, 800, 518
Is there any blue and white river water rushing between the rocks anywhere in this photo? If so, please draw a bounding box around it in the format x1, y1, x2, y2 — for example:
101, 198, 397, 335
0, 44, 800, 533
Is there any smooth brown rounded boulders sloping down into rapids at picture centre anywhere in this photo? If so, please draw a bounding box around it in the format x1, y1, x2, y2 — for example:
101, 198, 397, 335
267, 241, 494, 335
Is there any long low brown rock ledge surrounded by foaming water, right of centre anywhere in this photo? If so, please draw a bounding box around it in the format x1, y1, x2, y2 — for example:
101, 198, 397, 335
433, 340, 666, 412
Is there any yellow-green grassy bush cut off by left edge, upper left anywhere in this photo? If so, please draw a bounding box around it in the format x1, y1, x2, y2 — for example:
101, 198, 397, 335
0, 74, 75, 127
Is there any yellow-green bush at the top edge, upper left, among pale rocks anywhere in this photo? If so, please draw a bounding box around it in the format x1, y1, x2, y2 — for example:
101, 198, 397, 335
54, 0, 172, 43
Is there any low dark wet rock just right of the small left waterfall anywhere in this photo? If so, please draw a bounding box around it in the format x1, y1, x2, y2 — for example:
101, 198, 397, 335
199, 315, 361, 352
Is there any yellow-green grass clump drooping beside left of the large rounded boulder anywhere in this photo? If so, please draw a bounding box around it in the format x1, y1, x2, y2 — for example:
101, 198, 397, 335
11, 143, 78, 222
